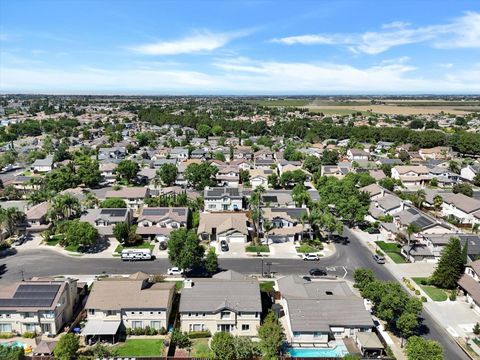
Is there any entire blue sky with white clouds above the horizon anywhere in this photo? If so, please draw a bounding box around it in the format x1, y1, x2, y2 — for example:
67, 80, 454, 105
0, 0, 480, 95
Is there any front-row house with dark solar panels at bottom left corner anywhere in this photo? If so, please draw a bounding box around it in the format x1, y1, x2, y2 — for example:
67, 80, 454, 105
0, 278, 79, 335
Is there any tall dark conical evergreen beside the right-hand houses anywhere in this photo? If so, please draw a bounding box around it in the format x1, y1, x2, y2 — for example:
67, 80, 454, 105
432, 237, 464, 289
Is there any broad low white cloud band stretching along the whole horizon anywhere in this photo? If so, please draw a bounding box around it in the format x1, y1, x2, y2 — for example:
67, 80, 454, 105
0, 58, 480, 94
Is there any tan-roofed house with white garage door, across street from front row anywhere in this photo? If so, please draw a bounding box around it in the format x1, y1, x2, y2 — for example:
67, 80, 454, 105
197, 213, 249, 243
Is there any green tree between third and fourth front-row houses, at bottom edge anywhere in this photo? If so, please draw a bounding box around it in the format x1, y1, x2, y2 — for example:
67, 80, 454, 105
258, 311, 285, 360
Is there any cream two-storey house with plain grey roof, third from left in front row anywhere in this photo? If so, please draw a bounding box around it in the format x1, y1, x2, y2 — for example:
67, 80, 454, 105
179, 275, 262, 337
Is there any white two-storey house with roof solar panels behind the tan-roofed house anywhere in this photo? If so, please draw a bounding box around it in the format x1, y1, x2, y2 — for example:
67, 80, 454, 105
203, 187, 243, 211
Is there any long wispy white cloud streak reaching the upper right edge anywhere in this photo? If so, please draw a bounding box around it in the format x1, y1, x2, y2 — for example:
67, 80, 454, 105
271, 12, 480, 55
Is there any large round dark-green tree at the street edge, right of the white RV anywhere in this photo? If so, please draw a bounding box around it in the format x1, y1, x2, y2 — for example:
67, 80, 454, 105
168, 228, 205, 269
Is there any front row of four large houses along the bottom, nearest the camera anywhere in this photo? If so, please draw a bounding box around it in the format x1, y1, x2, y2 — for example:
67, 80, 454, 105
0, 271, 382, 356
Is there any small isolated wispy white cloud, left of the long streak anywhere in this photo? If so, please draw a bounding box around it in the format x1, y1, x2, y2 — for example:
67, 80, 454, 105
129, 31, 247, 55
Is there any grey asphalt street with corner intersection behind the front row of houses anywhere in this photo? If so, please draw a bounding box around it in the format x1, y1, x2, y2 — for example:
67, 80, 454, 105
0, 229, 468, 360
